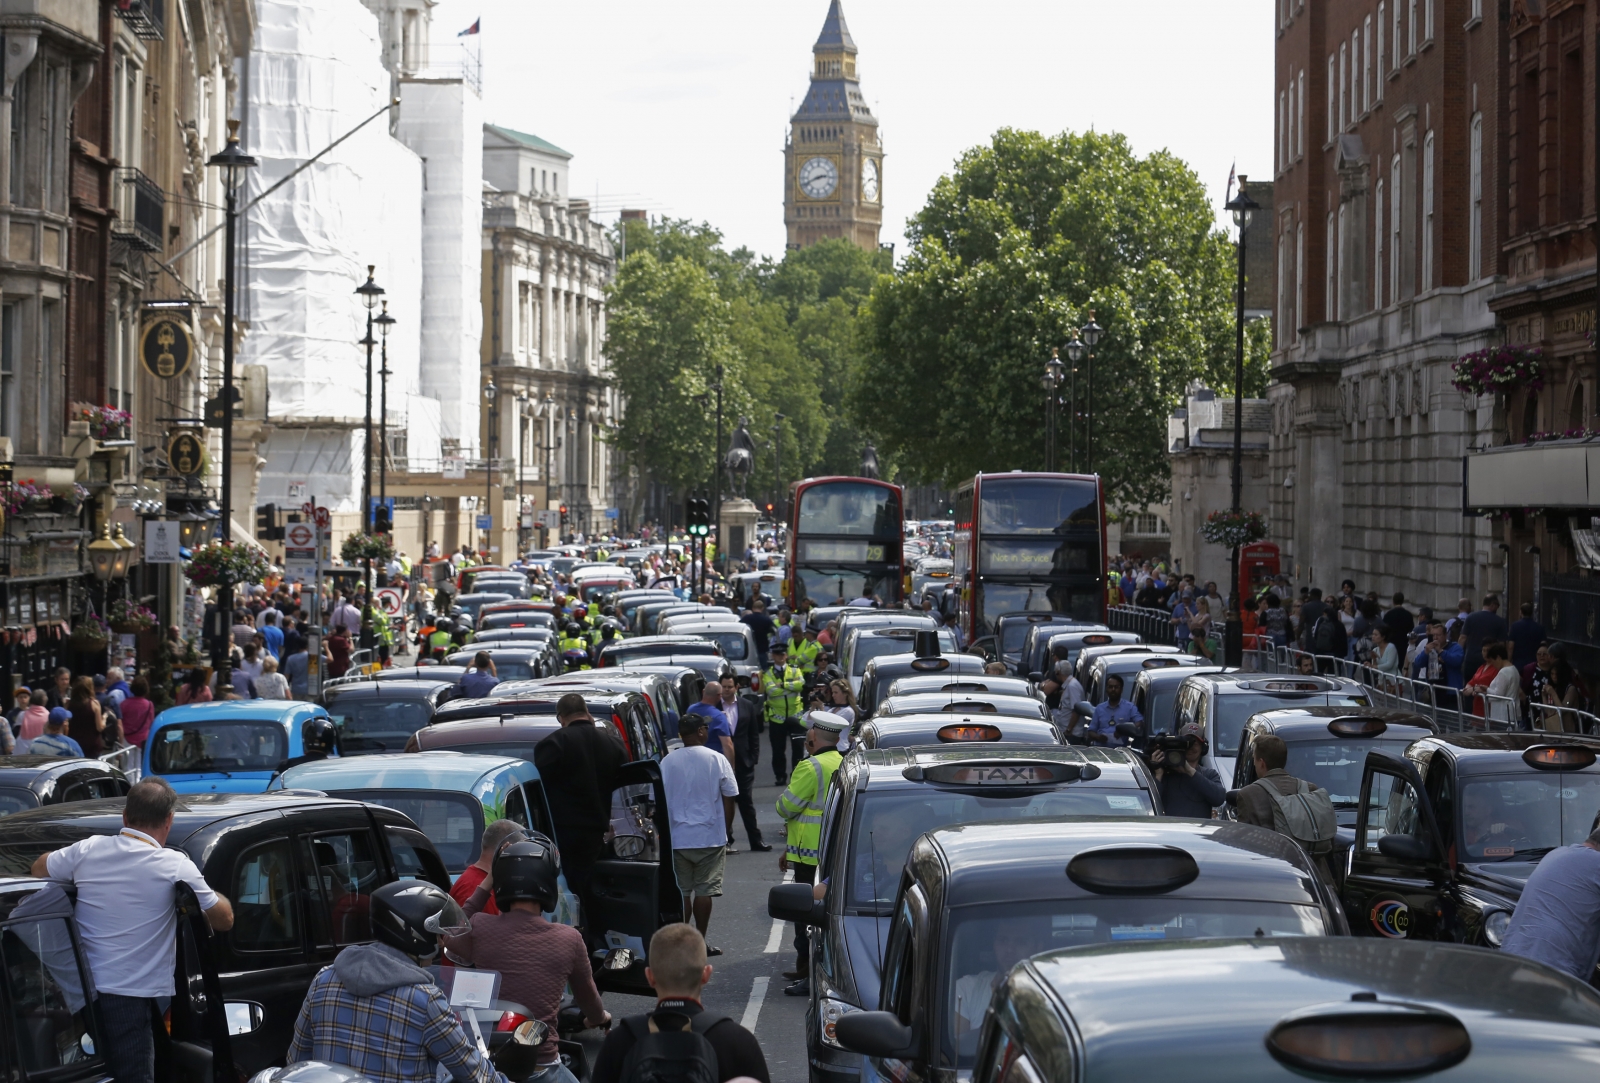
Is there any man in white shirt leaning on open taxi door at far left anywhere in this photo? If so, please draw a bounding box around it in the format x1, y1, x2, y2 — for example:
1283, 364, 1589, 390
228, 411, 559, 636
32, 777, 234, 1083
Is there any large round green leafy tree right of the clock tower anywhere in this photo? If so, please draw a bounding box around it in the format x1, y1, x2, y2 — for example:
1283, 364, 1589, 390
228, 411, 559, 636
848, 130, 1266, 507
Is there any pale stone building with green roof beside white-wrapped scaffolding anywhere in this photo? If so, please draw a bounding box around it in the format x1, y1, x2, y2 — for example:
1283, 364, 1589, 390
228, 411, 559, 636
483, 125, 626, 541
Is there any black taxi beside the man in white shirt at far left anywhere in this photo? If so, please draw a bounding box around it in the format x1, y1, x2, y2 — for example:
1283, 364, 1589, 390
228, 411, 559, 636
0, 792, 450, 1078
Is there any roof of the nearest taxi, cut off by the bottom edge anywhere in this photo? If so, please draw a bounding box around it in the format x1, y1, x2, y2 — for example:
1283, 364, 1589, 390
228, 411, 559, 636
1011, 936, 1600, 1083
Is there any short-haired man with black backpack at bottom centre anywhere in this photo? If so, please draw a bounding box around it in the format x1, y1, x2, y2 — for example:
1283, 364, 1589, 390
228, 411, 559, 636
589, 925, 771, 1083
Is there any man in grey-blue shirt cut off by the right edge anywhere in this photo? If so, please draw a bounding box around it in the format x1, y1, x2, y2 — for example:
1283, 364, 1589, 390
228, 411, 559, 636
1501, 829, 1600, 981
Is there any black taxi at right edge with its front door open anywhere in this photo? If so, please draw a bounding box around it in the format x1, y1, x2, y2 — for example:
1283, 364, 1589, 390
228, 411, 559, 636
1342, 733, 1600, 947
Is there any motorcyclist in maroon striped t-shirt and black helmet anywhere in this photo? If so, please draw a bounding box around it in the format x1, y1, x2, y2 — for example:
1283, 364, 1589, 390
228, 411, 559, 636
445, 833, 611, 1083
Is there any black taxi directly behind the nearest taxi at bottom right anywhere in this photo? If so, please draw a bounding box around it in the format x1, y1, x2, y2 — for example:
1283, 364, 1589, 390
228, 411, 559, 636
835, 817, 1349, 1080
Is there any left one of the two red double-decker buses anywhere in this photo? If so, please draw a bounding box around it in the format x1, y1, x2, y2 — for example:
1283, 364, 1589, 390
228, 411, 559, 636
784, 477, 906, 606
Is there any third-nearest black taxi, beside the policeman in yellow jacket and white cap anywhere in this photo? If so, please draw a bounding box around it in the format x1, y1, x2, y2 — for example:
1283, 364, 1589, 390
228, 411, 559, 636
768, 745, 1162, 1081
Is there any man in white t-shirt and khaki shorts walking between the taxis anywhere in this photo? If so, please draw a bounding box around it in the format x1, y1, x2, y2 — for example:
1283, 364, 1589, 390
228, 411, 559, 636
661, 713, 739, 955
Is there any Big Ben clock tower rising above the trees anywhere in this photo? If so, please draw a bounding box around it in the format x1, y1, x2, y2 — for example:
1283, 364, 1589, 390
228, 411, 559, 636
784, 0, 883, 251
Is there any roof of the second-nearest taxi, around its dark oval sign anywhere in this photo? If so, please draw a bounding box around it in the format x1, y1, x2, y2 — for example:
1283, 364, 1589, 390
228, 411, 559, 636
912, 816, 1320, 905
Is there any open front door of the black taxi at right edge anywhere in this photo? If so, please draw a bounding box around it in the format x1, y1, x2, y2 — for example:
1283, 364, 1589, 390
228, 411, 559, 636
1342, 749, 1451, 941
